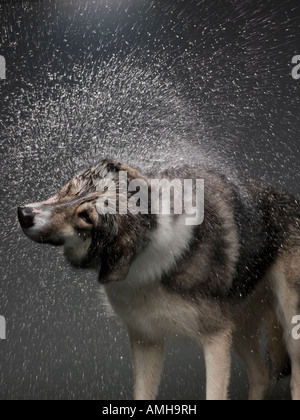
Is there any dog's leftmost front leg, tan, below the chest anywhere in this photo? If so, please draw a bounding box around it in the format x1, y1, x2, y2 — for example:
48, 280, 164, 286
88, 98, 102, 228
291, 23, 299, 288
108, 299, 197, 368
129, 333, 165, 400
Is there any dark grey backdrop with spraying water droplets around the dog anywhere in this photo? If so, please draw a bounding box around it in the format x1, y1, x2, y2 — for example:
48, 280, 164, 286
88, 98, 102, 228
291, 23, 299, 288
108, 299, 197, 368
0, 0, 300, 399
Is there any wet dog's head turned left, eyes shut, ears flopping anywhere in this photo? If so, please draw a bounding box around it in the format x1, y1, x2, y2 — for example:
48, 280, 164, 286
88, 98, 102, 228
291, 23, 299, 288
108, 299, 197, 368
18, 160, 155, 283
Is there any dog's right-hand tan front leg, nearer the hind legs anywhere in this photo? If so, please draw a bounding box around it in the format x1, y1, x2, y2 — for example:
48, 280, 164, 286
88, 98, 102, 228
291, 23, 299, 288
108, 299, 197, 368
203, 332, 232, 401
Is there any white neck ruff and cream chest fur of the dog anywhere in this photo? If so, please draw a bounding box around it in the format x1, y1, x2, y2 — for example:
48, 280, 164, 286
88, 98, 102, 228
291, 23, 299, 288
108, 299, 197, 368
105, 216, 198, 339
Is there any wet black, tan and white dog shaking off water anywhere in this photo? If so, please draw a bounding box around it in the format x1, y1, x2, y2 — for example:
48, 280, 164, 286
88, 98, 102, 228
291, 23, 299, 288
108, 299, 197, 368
18, 159, 300, 400
